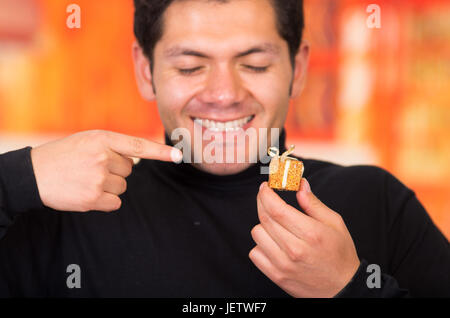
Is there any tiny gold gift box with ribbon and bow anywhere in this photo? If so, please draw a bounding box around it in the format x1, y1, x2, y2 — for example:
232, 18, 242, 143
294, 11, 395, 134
267, 145, 304, 191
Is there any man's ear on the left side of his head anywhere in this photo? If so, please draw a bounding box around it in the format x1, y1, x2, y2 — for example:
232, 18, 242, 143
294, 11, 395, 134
133, 42, 156, 101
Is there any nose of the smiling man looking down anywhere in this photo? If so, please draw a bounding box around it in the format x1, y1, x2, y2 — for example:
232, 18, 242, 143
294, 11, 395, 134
198, 65, 245, 107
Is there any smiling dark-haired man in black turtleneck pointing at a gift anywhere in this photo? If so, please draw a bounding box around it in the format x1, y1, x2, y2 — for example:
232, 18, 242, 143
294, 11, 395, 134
0, 0, 450, 297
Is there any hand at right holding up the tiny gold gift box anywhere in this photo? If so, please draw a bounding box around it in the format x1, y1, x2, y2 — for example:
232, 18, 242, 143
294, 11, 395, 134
249, 178, 360, 297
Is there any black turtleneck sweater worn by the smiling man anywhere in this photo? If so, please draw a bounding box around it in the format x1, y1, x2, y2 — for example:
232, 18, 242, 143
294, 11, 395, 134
0, 131, 450, 297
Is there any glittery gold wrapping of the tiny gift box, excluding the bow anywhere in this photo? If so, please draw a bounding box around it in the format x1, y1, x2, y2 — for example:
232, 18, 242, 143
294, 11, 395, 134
269, 158, 304, 191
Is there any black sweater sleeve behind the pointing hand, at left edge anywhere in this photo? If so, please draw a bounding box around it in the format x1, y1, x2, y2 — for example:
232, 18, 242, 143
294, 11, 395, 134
0, 147, 43, 239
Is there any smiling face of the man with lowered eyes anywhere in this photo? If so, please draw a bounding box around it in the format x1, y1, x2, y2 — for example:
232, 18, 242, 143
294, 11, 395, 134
135, 0, 306, 174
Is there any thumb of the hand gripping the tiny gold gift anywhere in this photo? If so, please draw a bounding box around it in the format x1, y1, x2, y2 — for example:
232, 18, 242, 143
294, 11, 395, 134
296, 178, 337, 225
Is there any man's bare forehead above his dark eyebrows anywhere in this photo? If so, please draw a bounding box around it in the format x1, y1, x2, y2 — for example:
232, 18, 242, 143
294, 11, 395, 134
156, 0, 283, 53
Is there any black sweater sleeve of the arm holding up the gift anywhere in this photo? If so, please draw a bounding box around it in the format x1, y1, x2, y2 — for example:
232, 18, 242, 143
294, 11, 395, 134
336, 172, 450, 298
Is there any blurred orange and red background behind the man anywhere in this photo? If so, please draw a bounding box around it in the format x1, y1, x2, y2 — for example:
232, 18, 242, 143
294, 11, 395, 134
0, 0, 450, 238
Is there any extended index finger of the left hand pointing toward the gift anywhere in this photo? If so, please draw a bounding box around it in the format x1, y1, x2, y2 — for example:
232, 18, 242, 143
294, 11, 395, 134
107, 132, 183, 162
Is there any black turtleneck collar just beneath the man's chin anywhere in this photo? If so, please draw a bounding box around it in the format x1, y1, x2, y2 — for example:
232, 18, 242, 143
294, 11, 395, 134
143, 129, 292, 189
